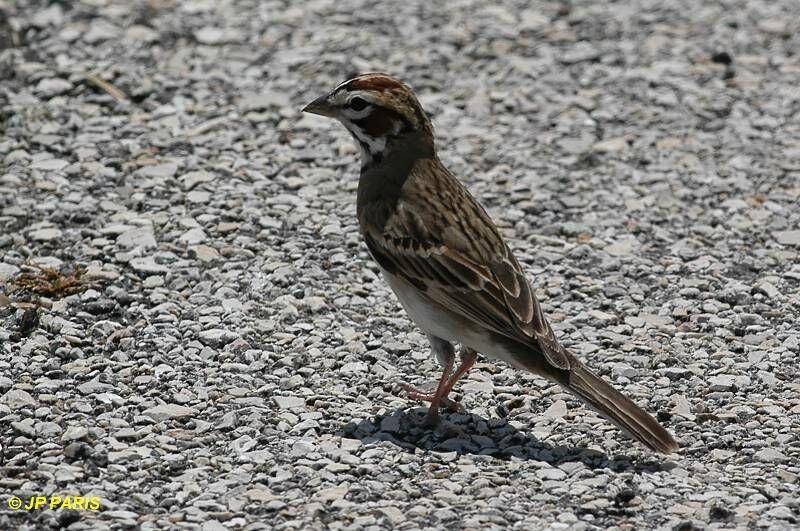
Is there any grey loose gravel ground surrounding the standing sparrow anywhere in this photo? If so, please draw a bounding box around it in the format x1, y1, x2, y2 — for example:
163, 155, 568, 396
0, 0, 800, 531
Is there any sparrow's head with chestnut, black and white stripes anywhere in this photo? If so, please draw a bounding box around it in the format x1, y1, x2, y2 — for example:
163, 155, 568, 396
303, 73, 433, 166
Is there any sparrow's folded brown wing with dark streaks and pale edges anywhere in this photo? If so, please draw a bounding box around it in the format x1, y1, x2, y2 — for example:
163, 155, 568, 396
364, 172, 574, 369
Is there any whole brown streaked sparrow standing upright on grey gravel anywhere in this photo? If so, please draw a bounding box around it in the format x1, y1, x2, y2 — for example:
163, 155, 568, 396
303, 72, 678, 454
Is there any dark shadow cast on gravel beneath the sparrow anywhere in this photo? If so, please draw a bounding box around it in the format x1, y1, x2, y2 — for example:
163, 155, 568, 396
337, 408, 674, 473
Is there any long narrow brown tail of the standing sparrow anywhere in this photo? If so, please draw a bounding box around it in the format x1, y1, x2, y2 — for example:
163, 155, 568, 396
561, 363, 678, 454
